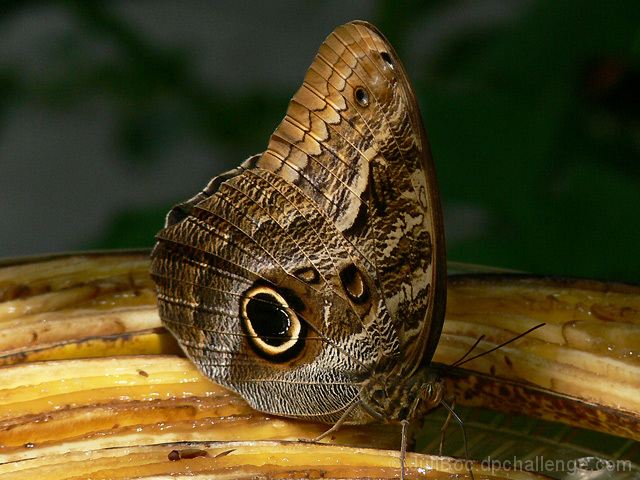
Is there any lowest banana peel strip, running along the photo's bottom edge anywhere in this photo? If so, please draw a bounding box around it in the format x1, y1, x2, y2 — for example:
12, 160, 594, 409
0, 441, 547, 480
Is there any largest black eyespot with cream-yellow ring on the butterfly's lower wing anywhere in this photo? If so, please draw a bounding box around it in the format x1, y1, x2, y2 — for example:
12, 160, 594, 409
240, 285, 306, 362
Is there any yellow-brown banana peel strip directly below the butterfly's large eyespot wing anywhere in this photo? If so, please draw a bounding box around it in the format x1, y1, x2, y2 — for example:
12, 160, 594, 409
0, 355, 400, 458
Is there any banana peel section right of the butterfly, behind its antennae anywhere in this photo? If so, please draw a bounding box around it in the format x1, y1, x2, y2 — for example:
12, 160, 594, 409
434, 275, 640, 441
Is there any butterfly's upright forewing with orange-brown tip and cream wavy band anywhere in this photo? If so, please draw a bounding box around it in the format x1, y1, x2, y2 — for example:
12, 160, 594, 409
258, 22, 446, 373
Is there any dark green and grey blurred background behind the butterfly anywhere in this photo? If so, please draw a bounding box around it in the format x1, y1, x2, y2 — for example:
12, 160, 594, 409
0, 0, 640, 282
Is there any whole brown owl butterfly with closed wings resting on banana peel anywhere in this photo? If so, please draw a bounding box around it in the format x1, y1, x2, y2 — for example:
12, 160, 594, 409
151, 21, 446, 440
